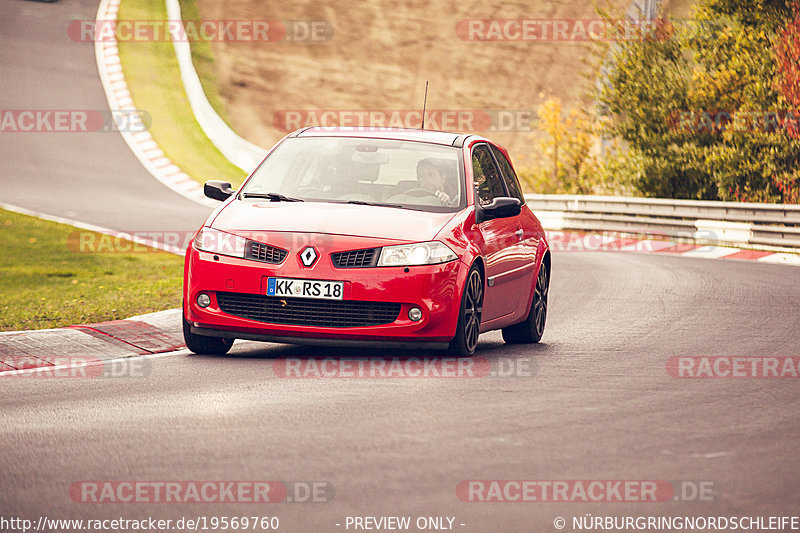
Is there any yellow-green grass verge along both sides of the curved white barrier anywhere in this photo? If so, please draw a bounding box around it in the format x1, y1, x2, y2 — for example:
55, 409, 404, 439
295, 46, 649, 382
119, 0, 244, 186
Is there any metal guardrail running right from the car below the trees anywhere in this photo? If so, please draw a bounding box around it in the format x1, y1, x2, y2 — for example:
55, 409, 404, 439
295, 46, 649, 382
525, 194, 800, 251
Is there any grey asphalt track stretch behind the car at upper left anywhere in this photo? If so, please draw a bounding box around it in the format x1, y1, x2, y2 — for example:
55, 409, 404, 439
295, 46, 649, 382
0, 0, 211, 232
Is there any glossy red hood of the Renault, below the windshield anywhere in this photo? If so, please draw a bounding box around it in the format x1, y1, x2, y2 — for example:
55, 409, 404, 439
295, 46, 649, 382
211, 200, 455, 241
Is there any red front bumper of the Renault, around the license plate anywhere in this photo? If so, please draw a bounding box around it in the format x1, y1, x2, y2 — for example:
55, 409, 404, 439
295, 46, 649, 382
183, 238, 468, 347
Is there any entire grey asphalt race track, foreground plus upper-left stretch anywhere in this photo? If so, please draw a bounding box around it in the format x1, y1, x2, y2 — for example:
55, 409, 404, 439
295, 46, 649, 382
0, 0, 800, 532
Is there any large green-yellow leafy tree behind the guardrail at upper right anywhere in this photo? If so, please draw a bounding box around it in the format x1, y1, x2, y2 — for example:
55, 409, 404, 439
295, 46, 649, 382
599, 0, 800, 201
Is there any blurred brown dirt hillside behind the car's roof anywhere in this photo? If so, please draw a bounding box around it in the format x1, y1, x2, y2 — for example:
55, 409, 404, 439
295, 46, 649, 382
198, 0, 629, 162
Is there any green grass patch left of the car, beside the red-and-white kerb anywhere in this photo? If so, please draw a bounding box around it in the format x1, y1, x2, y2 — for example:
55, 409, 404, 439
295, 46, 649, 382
0, 210, 183, 331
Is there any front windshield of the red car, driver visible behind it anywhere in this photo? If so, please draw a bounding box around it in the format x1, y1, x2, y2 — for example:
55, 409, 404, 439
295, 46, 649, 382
241, 137, 466, 212
